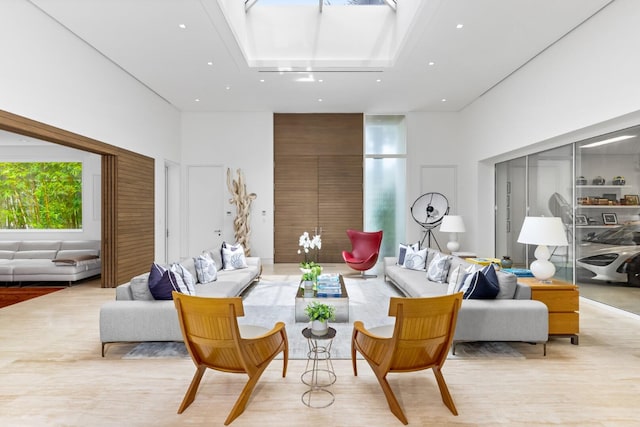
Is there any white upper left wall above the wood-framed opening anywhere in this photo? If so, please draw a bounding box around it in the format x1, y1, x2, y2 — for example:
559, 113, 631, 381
0, 0, 180, 259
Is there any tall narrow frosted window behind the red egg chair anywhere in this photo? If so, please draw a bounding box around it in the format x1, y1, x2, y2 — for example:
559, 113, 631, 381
364, 116, 407, 257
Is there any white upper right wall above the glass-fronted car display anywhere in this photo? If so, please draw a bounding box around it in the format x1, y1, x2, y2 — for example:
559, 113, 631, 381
461, 0, 640, 256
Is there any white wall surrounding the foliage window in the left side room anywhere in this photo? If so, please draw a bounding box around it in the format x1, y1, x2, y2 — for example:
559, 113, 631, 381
0, 144, 101, 240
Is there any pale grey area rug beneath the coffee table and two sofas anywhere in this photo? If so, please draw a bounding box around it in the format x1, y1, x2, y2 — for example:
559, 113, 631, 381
123, 278, 524, 359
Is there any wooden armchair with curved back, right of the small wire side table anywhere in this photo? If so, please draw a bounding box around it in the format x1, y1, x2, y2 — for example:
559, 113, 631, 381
351, 292, 462, 424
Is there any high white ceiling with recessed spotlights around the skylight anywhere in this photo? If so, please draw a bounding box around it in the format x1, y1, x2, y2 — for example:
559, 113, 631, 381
28, 0, 611, 113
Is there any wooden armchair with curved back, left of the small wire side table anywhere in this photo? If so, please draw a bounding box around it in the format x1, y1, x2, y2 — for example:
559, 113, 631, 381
173, 292, 289, 425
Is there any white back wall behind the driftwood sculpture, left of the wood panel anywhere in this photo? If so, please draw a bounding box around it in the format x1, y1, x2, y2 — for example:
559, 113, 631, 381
180, 112, 272, 264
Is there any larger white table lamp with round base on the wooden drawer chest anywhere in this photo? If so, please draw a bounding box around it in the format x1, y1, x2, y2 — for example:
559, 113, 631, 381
518, 216, 569, 282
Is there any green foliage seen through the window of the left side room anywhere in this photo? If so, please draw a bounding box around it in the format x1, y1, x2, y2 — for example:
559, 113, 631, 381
0, 162, 82, 230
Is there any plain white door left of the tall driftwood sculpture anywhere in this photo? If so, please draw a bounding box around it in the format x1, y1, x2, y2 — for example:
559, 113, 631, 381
187, 166, 226, 256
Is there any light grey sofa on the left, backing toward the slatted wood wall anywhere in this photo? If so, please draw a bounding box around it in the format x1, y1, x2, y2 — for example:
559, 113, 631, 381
100, 250, 262, 357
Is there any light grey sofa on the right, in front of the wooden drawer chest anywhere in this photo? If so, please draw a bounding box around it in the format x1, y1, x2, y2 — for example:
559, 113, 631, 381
384, 254, 549, 354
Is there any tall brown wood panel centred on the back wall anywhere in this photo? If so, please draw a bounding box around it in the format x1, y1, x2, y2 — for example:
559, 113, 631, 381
274, 114, 364, 262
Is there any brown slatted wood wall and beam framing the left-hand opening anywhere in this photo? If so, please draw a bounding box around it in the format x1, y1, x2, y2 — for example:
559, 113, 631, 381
0, 110, 155, 288
